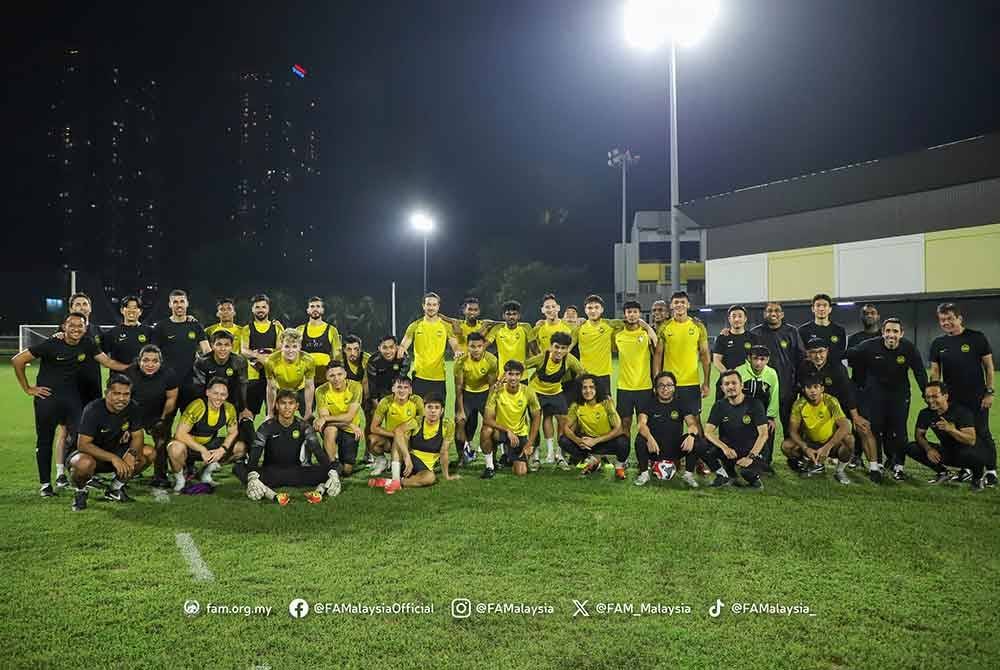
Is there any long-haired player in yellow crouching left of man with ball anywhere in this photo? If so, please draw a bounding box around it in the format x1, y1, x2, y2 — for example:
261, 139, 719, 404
559, 373, 629, 480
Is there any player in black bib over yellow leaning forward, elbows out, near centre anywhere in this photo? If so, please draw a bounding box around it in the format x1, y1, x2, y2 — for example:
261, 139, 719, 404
524, 331, 583, 470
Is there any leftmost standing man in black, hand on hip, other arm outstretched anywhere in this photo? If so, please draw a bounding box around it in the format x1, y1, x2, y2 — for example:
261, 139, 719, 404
11, 312, 127, 497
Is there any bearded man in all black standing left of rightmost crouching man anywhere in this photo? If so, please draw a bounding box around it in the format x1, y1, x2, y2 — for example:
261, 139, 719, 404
847, 317, 927, 481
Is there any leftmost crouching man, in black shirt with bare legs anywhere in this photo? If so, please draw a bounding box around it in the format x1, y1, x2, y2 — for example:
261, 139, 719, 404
66, 374, 153, 512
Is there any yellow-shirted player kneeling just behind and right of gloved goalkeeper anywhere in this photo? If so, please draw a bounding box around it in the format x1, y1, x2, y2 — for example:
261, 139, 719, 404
313, 359, 364, 477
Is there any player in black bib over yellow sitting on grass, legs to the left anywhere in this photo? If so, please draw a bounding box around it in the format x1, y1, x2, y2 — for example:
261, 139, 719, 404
368, 391, 459, 495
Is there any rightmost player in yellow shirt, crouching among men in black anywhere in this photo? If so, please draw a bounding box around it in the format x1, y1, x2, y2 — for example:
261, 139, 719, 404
781, 376, 854, 484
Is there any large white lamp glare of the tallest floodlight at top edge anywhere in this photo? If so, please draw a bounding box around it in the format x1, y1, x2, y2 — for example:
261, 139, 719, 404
625, 0, 719, 50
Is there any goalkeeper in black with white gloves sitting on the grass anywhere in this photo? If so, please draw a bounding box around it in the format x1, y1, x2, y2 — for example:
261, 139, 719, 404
233, 389, 340, 505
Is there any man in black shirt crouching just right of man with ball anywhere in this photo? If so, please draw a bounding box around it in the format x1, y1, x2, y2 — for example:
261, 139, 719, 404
702, 370, 768, 489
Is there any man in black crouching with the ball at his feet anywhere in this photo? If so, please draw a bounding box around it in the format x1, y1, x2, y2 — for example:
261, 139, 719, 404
635, 370, 707, 489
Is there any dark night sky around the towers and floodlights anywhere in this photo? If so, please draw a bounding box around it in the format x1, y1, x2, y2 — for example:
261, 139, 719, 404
3, 0, 1000, 304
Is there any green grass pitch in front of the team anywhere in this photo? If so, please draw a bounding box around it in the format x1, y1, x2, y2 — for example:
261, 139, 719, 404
0, 366, 1000, 670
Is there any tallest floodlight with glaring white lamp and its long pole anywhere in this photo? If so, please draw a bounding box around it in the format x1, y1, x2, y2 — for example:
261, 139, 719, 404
620, 0, 719, 293
